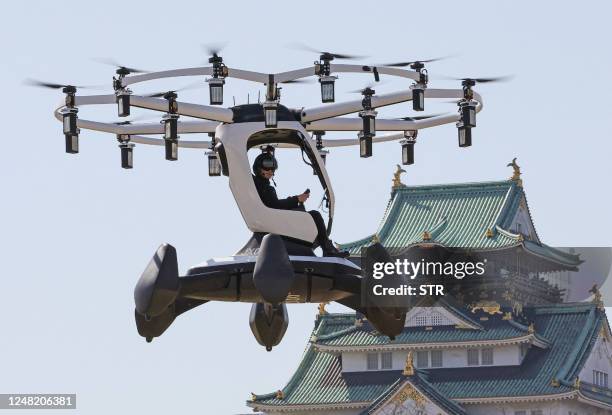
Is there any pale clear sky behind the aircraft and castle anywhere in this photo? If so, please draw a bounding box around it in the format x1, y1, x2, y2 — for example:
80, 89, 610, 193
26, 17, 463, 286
0, 0, 612, 414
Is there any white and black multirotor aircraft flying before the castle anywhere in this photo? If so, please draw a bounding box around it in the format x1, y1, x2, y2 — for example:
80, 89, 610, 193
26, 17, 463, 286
38, 48, 502, 350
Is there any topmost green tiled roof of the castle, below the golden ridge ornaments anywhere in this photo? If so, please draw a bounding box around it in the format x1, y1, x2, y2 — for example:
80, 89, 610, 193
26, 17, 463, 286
340, 180, 580, 266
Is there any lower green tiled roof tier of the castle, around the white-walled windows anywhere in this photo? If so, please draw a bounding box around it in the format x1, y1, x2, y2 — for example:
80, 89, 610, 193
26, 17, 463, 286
247, 303, 612, 413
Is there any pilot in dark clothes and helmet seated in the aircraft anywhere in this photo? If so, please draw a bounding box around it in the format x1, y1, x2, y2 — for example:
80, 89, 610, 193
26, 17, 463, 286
253, 152, 349, 258
